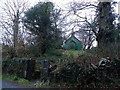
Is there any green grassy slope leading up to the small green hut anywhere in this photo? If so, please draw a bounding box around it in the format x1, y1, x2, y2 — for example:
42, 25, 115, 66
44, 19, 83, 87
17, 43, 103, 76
36, 49, 86, 70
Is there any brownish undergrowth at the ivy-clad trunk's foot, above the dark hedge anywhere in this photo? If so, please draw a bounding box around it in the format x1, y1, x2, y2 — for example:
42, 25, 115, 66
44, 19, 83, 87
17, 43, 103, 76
87, 42, 120, 58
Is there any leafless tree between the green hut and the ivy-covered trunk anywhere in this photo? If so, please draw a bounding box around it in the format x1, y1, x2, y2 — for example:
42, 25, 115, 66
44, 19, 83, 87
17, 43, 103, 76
61, 2, 98, 49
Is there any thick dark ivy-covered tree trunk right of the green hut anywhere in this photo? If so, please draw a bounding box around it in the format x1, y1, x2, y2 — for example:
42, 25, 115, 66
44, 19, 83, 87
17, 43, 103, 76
96, 2, 114, 46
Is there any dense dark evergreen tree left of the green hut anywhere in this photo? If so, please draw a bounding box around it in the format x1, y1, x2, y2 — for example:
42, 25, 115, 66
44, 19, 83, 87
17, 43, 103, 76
23, 2, 61, 54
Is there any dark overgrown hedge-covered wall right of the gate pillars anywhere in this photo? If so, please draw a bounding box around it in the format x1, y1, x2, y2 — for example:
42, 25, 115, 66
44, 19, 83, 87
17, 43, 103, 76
51, 58, 120, 88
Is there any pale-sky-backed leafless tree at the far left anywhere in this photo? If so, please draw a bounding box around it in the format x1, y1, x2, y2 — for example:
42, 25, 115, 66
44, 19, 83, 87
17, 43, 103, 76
0, 0, 28, 55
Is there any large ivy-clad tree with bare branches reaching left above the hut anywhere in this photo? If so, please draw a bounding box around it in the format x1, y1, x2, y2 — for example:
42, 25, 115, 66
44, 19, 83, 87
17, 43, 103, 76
64, 0, 115, 47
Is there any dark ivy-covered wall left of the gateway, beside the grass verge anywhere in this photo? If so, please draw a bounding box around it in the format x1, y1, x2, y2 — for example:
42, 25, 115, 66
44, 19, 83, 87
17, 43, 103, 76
2, 58, 34, 80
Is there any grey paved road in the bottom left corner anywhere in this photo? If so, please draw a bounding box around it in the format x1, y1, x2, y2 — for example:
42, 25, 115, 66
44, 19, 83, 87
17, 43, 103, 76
0, 80, 32, 88
